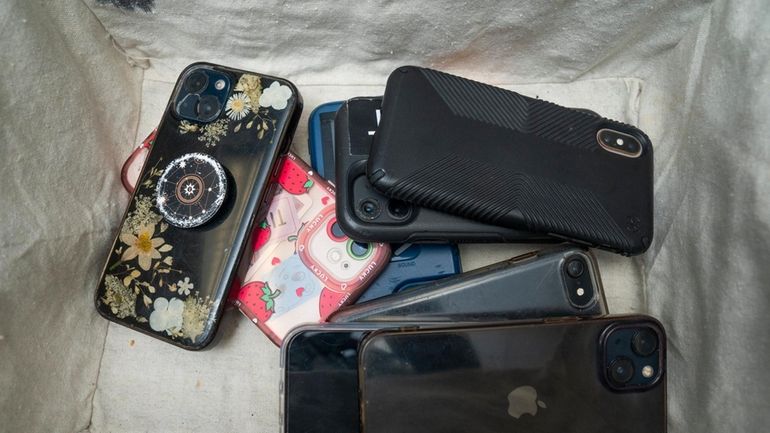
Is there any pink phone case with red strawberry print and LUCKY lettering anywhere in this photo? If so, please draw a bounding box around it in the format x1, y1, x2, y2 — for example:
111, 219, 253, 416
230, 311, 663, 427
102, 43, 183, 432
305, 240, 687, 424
234, 153, 390, 345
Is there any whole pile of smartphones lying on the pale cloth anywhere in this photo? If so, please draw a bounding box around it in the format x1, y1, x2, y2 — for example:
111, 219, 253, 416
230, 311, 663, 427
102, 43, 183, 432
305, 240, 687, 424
95, 64, 666, 433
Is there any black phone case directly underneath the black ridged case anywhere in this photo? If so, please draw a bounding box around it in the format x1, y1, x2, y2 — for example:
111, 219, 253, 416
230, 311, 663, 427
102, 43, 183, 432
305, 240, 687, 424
334, 97, 556, 243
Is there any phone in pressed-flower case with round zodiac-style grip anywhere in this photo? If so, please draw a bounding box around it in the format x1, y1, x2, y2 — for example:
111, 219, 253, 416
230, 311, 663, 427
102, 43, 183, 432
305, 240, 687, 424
95, 63, 302, 350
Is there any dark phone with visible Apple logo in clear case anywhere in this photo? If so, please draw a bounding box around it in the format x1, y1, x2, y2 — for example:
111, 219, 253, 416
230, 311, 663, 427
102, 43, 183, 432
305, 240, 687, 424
358, 316, 666, 433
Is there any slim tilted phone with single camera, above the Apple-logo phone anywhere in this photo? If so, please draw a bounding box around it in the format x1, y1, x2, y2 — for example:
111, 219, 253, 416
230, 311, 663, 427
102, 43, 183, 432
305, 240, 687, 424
329, 246, 607, 323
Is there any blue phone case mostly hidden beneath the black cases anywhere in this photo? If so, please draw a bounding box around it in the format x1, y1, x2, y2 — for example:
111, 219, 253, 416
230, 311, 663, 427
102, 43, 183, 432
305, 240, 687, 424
308, 101, 462, 303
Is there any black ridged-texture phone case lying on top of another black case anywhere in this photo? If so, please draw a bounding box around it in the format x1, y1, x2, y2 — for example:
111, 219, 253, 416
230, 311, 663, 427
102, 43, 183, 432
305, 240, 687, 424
368, 66, 653, 255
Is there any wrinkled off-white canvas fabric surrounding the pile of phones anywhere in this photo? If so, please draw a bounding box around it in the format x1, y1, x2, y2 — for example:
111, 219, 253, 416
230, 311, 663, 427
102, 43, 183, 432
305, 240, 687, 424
0, 0, 770, 432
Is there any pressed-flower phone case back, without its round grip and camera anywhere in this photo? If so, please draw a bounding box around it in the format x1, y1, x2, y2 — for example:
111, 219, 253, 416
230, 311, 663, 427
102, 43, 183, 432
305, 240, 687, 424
94, 63, 302, 350
